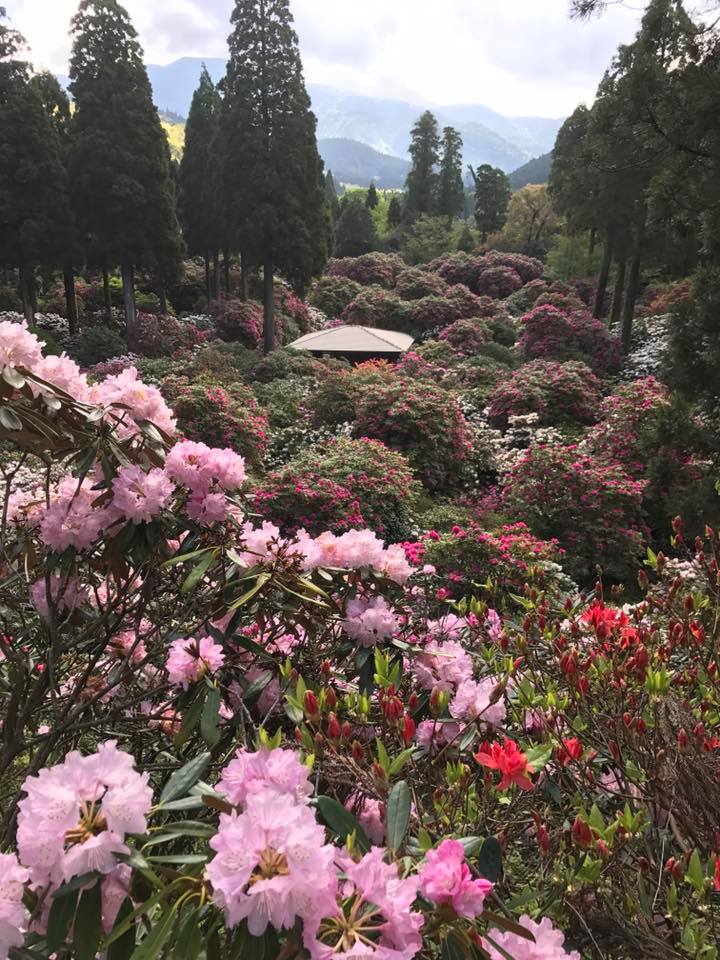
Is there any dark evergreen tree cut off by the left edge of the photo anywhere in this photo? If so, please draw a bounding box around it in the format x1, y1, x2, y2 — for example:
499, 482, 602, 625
0, 7, 71, 323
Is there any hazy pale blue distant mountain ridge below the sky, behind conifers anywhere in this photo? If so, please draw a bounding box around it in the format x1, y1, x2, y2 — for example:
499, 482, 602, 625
59, 57, 562, 172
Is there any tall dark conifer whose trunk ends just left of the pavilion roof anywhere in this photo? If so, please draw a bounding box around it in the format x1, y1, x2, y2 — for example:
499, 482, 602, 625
221, 0, 330, 352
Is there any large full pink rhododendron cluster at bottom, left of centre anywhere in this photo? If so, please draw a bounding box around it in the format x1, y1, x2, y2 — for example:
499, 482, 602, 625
207, 790, 334, 937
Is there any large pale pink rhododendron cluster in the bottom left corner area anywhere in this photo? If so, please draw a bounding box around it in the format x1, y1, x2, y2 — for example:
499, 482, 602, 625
17, 740, 152, 886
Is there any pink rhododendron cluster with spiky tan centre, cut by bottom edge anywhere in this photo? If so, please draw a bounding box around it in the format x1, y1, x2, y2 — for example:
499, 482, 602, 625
304, 847, 424, 960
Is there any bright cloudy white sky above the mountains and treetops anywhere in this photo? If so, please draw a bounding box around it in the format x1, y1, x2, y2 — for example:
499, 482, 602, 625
3, 0, 641, 117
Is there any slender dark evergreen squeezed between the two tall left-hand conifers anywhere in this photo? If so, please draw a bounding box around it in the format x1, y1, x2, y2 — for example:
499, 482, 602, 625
179, 64, 222, 298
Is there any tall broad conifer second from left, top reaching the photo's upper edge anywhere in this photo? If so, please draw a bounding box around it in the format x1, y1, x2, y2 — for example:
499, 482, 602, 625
69, 0, 182, 339
